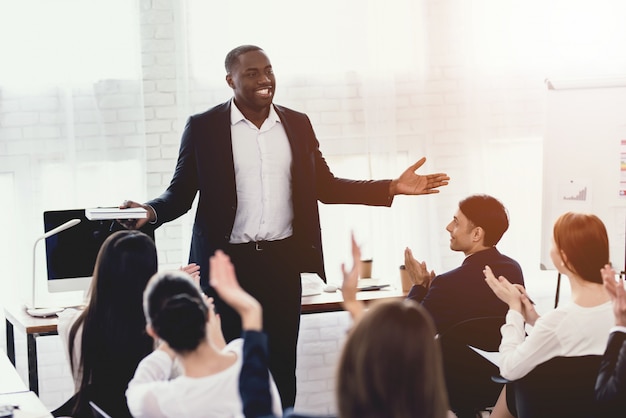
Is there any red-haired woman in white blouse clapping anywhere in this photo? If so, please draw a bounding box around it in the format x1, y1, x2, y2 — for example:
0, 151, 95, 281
485, 212, 613, 418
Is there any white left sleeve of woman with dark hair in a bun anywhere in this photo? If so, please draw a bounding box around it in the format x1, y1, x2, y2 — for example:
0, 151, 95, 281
126, 350, 173, 418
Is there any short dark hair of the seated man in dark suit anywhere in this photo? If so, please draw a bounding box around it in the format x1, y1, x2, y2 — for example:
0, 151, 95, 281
459, 194, 509, 247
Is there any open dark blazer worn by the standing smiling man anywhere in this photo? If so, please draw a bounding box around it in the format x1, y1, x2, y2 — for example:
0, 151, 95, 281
147, 101, 393, 287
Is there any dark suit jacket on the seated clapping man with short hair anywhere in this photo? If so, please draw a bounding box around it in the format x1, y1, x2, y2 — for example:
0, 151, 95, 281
407, 247, 524, 333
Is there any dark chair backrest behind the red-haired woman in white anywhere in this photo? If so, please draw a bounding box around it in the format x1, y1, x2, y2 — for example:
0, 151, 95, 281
507, 355, 602, 418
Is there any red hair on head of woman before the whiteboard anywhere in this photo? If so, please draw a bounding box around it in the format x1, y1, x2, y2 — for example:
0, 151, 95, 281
553, 212, 609, 284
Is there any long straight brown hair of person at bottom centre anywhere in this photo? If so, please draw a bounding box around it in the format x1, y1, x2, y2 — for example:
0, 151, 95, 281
336, 300, 448, 418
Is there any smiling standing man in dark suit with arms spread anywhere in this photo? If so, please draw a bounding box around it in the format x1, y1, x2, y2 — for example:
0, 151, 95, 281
121, 45, 449, 407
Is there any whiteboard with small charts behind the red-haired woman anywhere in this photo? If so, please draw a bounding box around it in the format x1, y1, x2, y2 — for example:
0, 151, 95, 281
540, 82, 626, 271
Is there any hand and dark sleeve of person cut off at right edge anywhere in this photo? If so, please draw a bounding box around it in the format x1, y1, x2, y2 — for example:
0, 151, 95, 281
596, 264, 626, 417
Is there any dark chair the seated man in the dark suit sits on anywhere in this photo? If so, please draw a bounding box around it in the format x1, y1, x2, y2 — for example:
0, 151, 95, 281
438, 316, 505, 418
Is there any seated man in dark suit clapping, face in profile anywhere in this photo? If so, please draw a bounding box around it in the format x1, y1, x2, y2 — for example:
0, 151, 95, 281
404, 195, 524, 333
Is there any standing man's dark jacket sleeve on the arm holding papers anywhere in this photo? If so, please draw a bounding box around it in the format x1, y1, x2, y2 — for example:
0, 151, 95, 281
146, 117, 198, 227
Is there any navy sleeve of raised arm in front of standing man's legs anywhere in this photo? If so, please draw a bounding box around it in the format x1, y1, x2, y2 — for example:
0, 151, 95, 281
239, 331, 274, 418
